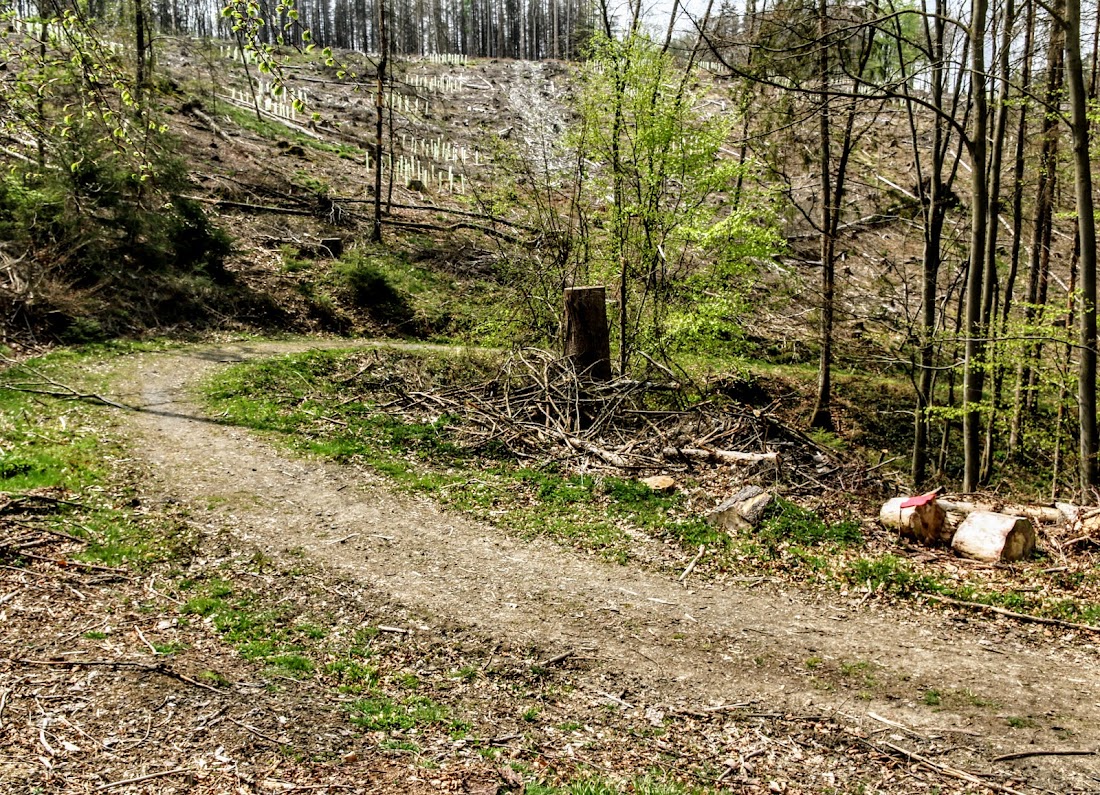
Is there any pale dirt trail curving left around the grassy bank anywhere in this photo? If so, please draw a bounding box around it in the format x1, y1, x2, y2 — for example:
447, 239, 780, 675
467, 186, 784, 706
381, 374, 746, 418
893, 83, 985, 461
116, 343, 1100, 792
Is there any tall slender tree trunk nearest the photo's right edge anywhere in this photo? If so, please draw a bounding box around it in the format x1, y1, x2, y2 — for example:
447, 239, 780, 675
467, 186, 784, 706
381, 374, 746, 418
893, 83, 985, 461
1065, 0, 1098, 503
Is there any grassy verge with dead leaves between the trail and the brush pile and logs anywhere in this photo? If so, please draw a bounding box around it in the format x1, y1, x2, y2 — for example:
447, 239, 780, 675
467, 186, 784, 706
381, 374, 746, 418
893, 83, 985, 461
206, 351, 1100, 622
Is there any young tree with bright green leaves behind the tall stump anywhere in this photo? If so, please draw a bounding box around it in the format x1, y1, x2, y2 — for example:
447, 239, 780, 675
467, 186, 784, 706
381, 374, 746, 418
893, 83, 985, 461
571, 30, 743, 371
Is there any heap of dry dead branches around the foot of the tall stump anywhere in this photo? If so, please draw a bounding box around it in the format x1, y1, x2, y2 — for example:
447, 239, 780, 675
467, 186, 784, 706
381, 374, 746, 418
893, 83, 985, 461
348, 350, 866, 492
